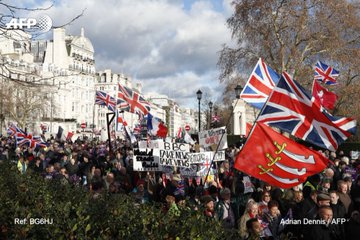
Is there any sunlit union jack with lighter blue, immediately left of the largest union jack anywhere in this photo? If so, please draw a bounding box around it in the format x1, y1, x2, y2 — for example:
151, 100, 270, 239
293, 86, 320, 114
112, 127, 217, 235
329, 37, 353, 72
240, 58, 280, 109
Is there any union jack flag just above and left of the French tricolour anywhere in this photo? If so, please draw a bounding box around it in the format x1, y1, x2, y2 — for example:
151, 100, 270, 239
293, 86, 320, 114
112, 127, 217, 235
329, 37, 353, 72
117, 83, 150, 115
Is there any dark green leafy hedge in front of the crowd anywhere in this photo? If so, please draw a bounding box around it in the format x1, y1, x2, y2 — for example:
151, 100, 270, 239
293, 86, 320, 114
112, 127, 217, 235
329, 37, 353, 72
0, 162, 238, 240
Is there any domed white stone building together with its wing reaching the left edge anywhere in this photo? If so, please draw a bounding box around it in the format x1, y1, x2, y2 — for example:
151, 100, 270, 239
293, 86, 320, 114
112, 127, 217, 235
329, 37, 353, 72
0, 28, 95, 134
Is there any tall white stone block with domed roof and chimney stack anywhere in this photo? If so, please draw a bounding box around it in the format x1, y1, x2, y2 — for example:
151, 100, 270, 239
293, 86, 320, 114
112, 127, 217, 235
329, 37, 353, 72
37, 28, 96, 133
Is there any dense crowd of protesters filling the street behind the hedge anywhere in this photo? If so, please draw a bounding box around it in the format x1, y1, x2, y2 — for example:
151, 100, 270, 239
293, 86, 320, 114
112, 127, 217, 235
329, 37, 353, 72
0, 137, 360, 240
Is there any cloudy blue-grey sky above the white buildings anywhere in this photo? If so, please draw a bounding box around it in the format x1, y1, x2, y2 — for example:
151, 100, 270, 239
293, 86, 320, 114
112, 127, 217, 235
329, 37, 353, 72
21, 0, 233, 108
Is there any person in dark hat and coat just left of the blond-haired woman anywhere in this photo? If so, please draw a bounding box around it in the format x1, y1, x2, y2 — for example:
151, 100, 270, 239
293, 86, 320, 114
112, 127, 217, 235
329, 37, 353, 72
215, 188, 235, 229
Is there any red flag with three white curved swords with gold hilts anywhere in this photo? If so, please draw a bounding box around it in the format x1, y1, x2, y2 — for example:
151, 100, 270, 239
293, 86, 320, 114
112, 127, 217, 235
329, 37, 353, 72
235, 123, 328, 188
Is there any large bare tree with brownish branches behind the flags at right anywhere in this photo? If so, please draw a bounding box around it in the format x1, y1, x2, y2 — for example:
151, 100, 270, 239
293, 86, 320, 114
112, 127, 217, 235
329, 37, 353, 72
218, 0, 360, 138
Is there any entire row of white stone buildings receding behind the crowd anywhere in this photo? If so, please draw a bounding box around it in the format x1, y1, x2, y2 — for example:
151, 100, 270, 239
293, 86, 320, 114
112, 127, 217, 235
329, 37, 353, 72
0, 28, 197, 137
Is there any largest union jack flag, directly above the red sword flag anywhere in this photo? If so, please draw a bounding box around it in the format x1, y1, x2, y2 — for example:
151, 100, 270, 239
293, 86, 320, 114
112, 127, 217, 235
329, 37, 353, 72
258, 73, 356, 151
